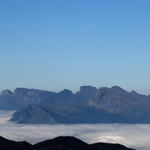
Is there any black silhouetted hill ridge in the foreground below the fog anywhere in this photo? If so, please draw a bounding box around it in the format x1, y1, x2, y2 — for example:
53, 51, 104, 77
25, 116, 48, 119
0, 136, 133, 150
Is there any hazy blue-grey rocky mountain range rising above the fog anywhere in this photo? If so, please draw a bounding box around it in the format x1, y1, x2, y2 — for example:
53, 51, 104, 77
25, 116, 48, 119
0, 86, 150, 124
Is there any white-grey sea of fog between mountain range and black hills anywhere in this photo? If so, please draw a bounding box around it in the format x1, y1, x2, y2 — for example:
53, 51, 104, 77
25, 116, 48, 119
0, 111, 150, 150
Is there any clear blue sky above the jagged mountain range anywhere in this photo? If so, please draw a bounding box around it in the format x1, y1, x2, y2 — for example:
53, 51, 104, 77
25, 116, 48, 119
0, 0, 150, 94
